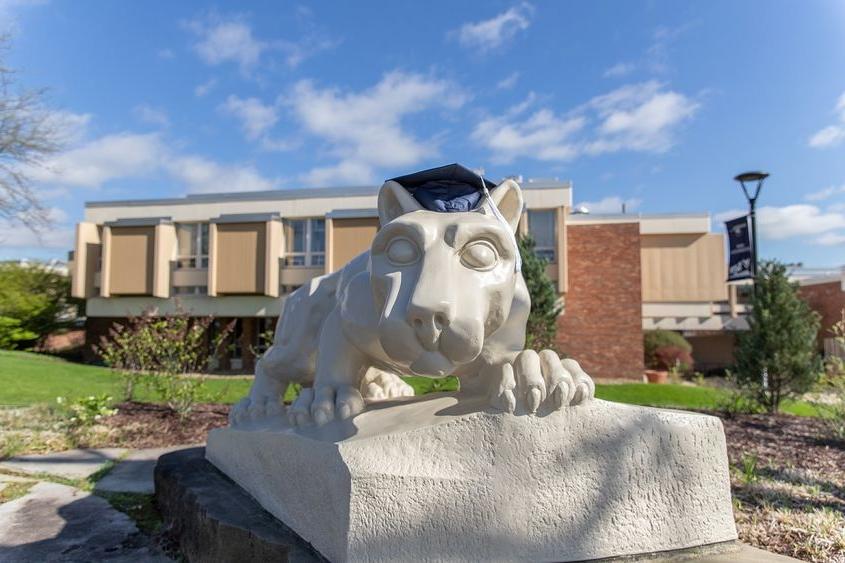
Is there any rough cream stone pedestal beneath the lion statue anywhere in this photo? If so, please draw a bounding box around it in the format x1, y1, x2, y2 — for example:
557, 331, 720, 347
206, 396, 736, 562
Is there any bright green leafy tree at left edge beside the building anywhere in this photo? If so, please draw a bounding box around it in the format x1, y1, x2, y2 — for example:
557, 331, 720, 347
0, 262, 75, 348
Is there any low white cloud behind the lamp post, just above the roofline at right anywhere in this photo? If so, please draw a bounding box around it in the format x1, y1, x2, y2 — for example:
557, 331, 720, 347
713, 204, 845, 242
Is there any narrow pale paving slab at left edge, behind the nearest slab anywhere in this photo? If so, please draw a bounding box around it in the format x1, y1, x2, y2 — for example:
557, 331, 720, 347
0, 448, 127, 479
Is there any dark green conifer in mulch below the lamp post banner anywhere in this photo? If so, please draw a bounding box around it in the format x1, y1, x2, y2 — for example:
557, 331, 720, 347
736, 261, 821, 413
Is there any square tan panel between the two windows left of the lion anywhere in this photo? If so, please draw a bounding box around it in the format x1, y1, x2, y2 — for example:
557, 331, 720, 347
214, 223, 267, 295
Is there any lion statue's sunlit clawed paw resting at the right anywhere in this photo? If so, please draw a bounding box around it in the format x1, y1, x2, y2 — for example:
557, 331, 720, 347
490, 350, 595, 413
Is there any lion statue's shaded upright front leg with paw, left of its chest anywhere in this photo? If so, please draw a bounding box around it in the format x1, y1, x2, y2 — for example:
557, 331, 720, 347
288, 307, 365, 426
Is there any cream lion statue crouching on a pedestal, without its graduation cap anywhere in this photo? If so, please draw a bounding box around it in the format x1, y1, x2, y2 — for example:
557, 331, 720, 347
230, 170, 595, 426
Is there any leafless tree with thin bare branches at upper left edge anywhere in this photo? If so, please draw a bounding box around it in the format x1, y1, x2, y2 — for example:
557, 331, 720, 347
0, 35, 60, 229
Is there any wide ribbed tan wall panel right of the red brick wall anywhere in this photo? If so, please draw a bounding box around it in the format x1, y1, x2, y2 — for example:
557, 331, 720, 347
640, 234, 728, 301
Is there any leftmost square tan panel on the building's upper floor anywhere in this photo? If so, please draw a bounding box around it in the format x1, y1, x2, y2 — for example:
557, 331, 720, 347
108, 227, 155, 295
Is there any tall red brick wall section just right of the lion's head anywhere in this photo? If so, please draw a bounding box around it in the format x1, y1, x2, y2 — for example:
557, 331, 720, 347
557, 223, 644, 380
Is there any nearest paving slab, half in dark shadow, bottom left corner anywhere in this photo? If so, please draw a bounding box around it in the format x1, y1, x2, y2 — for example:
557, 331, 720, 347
0, 482, 169, 563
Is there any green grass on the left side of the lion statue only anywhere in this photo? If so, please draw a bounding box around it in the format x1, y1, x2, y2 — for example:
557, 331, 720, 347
0, 351, 250, 406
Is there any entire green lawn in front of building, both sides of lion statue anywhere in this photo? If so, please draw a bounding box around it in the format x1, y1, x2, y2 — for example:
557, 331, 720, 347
0, 351, 814, 416
